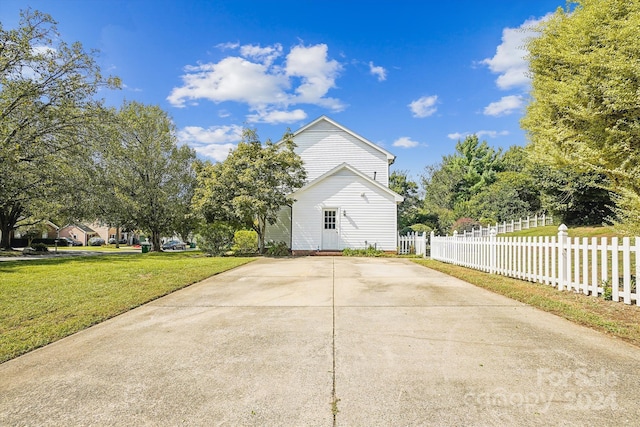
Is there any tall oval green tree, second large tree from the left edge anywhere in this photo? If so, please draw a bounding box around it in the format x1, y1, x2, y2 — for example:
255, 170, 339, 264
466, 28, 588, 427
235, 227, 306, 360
98, 102, 195, 251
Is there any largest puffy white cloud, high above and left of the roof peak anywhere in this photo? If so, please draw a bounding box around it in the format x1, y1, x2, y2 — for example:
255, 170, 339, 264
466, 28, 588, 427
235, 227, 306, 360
167, 43, 345, 121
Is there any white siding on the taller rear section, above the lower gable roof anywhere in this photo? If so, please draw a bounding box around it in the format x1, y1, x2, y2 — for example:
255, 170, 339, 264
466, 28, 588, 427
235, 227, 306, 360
294, 121, 389, 186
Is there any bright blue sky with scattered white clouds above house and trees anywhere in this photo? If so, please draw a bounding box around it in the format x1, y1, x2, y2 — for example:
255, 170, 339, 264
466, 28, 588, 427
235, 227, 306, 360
0, 0, 565, 179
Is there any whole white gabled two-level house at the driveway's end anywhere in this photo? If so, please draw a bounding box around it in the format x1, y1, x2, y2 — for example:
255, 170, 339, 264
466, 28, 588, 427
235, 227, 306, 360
266, 116, 404, 254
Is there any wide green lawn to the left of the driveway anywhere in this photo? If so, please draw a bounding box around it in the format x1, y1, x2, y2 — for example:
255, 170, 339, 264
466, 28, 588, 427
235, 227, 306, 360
0, 252, 253, 363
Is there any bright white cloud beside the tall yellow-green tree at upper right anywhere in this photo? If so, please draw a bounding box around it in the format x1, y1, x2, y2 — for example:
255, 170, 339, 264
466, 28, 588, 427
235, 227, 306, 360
481, 14, 551, 89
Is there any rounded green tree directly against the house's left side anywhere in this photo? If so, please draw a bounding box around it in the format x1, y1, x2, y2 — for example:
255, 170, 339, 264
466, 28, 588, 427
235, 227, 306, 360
195, 129, 306, 252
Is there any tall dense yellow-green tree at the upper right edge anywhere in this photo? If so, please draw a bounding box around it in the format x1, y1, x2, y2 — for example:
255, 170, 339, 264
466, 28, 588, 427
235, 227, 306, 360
522, 0, 640, 231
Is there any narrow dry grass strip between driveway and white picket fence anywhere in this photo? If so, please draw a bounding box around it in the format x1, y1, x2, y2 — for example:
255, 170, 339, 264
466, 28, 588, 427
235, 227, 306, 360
412, 259, 640, 346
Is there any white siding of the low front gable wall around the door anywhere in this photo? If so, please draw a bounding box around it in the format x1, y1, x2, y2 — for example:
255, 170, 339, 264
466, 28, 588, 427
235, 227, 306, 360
292, 170, 397, 251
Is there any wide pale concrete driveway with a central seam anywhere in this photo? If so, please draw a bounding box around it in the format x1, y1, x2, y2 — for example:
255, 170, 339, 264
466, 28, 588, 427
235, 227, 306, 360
0, 257, 640, 426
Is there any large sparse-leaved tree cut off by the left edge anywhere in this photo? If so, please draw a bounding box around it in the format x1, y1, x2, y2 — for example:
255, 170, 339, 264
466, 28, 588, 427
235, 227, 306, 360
0, 9, 119, 248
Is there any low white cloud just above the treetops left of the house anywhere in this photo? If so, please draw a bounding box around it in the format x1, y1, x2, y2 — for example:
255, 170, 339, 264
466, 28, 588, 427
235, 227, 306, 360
177, 125, 242, 162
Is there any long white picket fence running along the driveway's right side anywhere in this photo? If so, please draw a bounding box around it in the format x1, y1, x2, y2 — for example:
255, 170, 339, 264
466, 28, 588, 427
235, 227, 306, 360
431, 224, 640, 305
